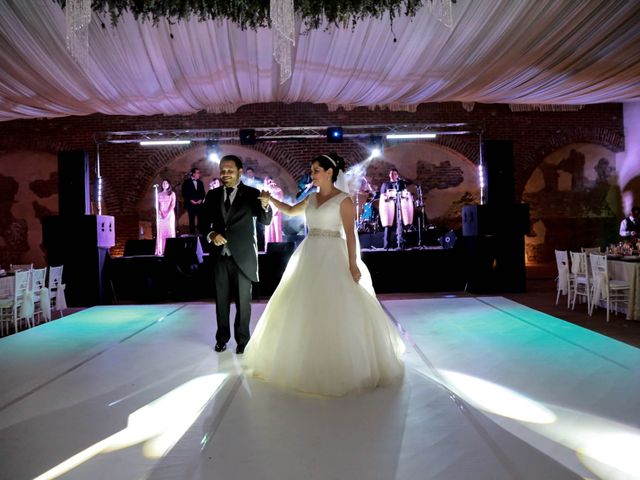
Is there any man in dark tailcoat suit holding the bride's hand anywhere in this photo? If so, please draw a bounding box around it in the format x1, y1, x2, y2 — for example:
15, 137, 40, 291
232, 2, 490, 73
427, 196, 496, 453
203, 155, 273, 354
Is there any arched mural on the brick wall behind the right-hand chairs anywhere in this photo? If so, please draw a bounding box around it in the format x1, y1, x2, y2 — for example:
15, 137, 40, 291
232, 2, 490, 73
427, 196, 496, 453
522, 143, 624, 262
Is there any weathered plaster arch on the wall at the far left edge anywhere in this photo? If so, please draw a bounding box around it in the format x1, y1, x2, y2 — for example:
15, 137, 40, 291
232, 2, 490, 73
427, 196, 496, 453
0, 151, 58, 268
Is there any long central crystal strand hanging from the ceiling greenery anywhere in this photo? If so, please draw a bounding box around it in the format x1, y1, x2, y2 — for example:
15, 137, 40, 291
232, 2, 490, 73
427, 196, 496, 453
269, 0, 296, 84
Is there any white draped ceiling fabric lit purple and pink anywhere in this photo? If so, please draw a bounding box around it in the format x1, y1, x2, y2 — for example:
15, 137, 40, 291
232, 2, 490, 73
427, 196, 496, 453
0, 0, 640, 121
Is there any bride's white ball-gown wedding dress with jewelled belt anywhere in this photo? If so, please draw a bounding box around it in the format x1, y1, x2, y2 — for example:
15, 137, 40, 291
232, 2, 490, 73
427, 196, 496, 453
244, 193, 404, 396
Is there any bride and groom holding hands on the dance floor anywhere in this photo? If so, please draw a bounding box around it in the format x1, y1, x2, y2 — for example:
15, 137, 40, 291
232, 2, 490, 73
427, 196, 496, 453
204, 153, 404, 396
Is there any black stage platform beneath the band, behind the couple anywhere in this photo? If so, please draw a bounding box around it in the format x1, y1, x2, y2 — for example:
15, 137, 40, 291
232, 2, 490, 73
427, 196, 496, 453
109, 242, 466, 302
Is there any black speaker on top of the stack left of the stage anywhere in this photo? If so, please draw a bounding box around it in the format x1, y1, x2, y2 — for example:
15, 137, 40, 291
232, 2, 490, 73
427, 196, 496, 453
58, 150, 91, 216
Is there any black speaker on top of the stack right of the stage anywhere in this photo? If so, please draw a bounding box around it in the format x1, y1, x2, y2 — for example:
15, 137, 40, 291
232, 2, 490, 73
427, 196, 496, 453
482, 140, 515, 205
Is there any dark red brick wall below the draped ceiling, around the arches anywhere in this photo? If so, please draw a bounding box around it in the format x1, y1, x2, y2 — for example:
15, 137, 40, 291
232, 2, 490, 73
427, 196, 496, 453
0, 102, 624, 254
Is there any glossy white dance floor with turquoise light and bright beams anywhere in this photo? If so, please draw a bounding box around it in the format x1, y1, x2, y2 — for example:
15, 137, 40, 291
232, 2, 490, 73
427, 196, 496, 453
0, 297, 640, 480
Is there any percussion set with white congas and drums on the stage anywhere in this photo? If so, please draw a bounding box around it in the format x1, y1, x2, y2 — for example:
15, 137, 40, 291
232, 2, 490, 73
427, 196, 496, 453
354, 179, 425, 245
